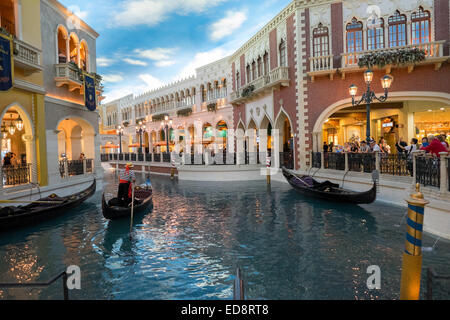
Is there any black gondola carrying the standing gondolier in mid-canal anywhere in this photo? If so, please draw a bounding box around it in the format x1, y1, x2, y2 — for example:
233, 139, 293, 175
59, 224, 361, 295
102, 187, 153, 220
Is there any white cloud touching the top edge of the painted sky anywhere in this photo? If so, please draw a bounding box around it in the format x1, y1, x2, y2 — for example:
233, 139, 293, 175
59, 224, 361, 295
114, 0, 227, 27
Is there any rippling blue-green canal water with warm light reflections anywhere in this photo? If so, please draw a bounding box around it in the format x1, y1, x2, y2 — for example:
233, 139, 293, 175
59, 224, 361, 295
0, 172, 450, 300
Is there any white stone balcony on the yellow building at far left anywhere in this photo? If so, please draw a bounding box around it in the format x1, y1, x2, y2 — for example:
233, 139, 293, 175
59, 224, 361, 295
14, 39, 43, 75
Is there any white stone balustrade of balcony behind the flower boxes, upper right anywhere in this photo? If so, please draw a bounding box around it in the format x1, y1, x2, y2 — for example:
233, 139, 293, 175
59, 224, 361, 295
341, 40, 445, 68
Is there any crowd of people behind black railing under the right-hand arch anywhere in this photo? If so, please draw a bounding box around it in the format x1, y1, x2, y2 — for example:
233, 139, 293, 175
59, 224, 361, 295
323, 134, 450, 156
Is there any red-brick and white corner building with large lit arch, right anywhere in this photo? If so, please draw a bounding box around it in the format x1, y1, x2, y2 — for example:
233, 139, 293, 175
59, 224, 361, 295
230, 0, 450, 169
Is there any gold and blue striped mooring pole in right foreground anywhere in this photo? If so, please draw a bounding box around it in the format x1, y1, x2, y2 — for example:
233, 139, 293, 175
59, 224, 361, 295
400, 184, 430, 300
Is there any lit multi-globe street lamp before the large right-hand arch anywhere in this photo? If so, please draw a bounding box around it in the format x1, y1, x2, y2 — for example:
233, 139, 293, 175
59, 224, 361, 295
349, 70, 393, 143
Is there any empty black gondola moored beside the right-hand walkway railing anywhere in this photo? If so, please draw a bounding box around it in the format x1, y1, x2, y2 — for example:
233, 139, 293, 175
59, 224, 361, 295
282, 168, 377, 204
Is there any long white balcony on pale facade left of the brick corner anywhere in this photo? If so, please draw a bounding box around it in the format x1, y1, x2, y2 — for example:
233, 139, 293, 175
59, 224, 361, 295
230, 67, 290, 104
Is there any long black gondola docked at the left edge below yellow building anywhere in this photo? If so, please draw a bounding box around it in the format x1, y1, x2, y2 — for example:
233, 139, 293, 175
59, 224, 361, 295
0, 179, 96, 231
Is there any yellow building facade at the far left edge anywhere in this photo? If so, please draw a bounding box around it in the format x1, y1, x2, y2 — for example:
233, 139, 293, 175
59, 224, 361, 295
0, 0, 48, 197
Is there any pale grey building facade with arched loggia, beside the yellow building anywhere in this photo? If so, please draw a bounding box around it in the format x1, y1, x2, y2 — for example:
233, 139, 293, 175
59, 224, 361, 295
40, 0, 101, 184
